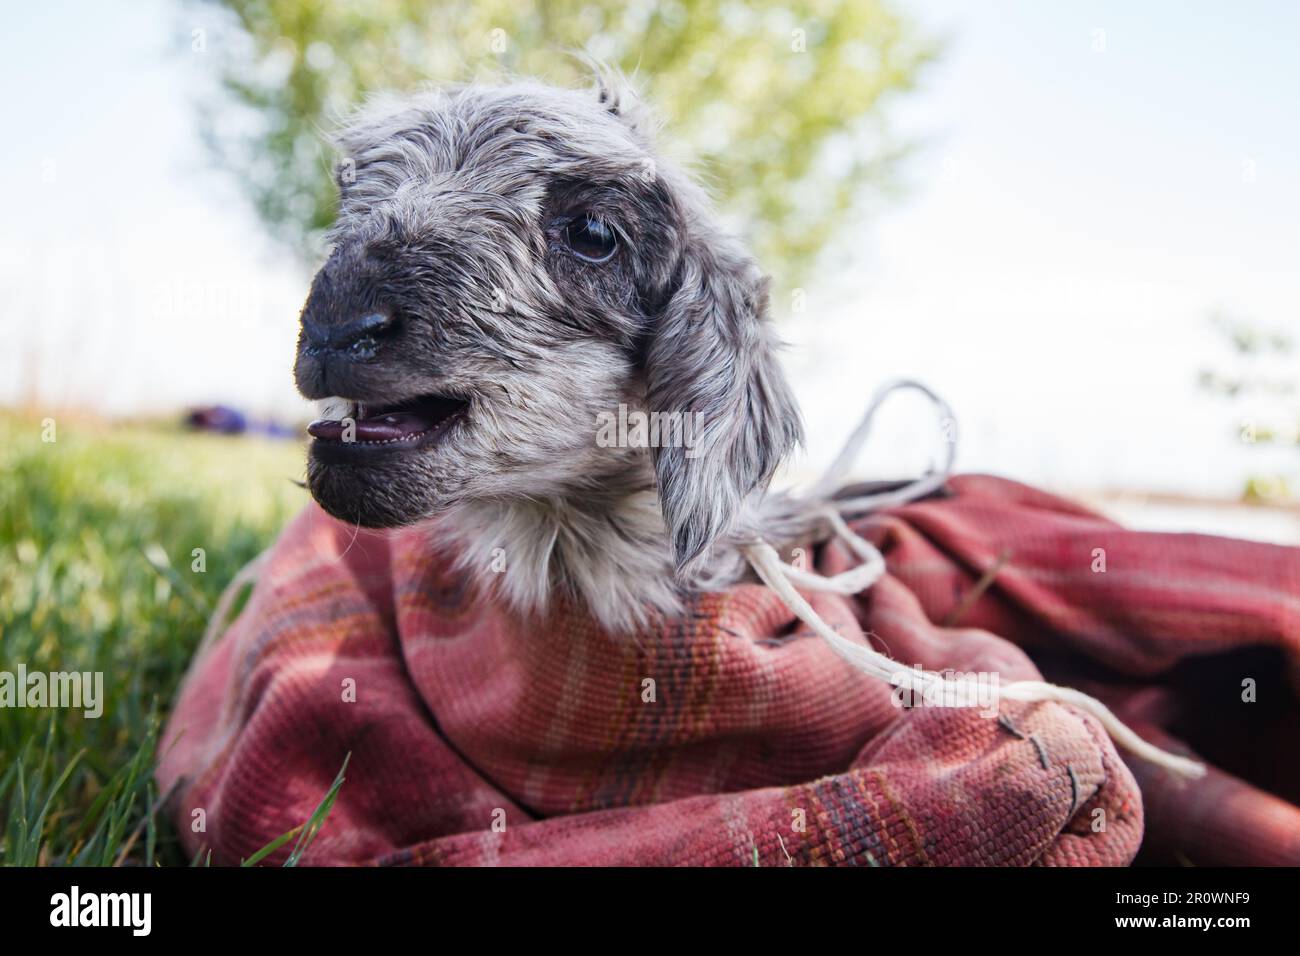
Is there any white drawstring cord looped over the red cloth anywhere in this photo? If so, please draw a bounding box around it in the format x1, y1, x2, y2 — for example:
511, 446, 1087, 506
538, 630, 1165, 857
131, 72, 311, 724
744, 380, 1205, 778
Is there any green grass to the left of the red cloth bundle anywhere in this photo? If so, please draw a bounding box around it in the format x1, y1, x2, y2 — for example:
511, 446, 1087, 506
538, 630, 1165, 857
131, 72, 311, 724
0, 414, 309, 866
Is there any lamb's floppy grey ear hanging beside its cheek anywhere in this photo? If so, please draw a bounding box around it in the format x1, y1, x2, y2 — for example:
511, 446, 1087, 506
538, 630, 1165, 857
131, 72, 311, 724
645, 221, 803, 576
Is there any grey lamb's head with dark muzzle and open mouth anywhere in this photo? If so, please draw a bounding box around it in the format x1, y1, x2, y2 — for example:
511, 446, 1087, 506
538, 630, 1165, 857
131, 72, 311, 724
295, 82, 800, 570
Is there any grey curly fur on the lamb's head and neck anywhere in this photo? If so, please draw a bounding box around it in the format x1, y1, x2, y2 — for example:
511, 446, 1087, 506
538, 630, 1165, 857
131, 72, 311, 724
295, 74, 811, 632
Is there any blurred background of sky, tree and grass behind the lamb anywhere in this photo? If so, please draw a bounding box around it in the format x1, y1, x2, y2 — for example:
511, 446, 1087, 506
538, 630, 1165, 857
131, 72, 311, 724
0, 0, 1300, 862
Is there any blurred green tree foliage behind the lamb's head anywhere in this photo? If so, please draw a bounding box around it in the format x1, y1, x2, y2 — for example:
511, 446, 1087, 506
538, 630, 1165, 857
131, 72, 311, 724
197, 0, 933, 285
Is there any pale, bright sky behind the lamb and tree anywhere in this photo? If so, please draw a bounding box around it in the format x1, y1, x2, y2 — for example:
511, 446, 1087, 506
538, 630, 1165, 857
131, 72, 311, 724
0, 0, 1300, 502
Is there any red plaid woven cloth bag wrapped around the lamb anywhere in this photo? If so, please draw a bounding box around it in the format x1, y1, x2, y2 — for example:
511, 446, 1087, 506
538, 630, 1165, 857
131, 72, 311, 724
159, 476, 1300, 866
